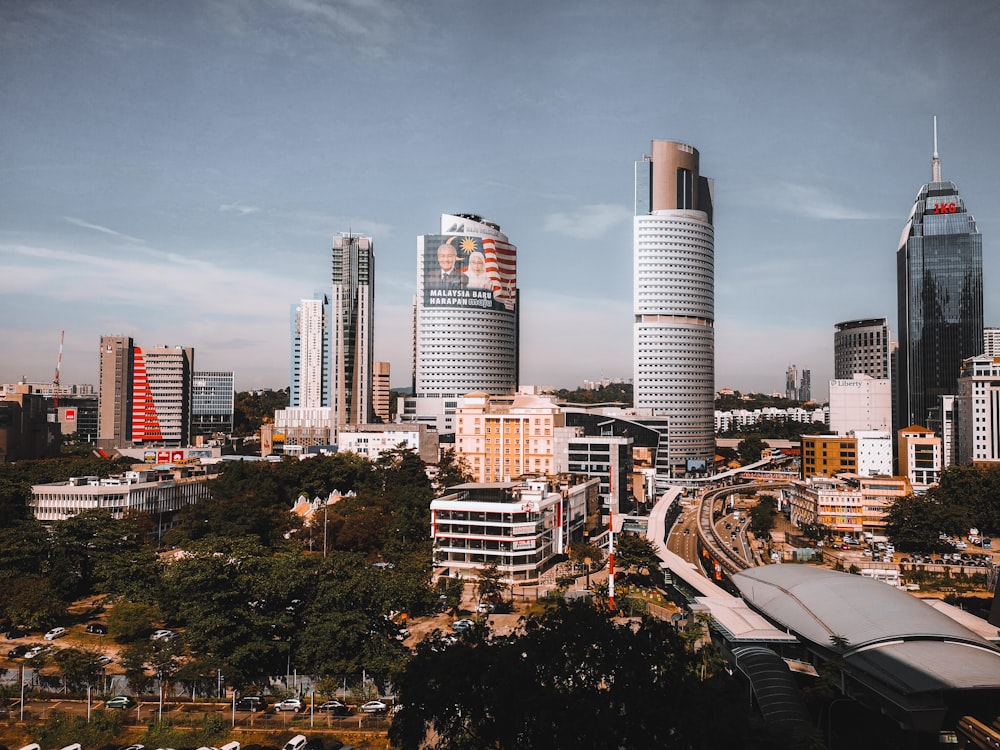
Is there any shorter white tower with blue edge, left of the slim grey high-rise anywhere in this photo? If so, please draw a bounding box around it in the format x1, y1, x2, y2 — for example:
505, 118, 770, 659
288, 292, 330, 409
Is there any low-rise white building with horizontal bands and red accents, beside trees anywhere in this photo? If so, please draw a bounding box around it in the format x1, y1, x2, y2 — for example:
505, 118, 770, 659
431, 478, 599, 584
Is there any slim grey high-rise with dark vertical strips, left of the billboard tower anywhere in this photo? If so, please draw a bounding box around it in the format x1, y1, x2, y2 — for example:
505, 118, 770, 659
330, 233, 375, 429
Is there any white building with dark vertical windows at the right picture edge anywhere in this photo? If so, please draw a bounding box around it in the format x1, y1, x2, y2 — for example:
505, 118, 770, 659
955, 355, 1000, 465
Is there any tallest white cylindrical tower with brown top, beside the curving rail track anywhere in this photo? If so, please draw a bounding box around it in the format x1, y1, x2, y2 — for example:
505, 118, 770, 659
633, 141, 715, 476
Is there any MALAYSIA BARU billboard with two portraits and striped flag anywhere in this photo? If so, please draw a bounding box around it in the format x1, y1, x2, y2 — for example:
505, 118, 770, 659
424, 234, 517, 311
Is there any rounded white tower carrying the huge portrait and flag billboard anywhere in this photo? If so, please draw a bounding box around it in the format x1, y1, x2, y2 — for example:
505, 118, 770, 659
401, 214, 520, 433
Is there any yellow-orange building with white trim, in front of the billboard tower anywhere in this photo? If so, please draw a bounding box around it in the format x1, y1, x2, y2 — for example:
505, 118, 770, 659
455, 393, 565, 482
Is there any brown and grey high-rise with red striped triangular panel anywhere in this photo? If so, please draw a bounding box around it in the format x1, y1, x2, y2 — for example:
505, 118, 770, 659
97, 336, 194, 448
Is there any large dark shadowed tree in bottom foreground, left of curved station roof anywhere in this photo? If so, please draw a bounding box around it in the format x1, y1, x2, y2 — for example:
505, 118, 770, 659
389, 602, 788, 750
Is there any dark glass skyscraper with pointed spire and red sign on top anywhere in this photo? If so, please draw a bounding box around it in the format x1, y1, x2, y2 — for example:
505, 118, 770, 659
896, 119, 983, 427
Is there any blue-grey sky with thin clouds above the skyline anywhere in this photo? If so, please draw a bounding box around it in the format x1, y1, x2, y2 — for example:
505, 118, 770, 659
0, 0, 1000, 399
